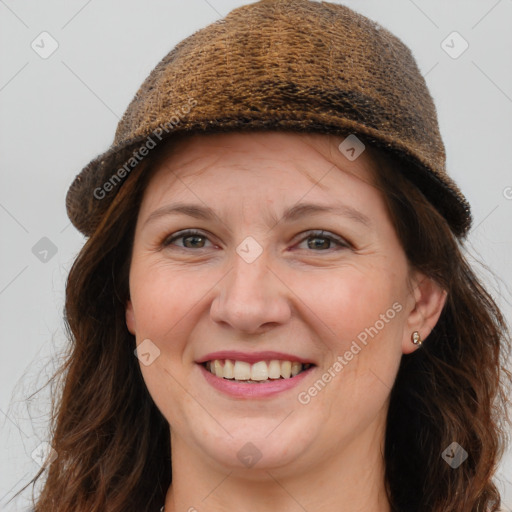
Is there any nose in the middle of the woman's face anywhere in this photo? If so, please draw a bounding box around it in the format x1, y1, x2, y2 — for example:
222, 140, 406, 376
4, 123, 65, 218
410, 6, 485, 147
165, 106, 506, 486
210, 251, 291, 334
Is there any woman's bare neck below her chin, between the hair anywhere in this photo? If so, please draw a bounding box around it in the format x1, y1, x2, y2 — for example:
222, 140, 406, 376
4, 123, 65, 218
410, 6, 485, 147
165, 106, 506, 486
165, 416, 391, 512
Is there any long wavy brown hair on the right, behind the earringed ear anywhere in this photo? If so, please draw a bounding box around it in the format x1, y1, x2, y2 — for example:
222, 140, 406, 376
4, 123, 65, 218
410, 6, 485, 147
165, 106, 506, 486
375, 155, 512, 512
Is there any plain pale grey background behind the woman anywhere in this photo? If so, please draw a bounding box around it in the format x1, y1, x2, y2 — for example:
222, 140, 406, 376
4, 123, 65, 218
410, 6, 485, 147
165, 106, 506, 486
0, 0, 512, 510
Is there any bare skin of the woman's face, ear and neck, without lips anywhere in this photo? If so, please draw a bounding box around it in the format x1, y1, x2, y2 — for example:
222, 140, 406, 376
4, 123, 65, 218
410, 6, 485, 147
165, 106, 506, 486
126, 132, 446, 512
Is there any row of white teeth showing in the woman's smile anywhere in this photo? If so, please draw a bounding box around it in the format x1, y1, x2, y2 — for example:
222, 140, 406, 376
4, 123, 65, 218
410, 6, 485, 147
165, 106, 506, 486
206, 359, 311, 383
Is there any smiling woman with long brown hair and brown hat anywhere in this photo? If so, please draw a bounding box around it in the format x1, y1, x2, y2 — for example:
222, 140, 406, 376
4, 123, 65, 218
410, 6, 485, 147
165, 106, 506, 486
21, 0, 510, 512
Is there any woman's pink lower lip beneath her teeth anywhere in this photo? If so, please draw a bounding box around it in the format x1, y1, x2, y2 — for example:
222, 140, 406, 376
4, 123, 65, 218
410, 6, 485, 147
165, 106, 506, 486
198, 364, 315, 398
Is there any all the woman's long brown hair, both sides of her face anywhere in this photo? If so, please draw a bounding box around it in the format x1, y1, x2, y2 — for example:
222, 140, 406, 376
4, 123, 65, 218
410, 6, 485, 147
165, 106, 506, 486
14, 132, 512, 512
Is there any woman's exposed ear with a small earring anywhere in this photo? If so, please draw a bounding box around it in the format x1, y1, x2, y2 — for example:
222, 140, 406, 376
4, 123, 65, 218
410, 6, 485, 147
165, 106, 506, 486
402, 272, 447, 354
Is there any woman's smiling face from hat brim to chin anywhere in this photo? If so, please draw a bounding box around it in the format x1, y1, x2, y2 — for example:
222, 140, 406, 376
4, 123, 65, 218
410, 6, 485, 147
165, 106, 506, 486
126, 132, 437, 480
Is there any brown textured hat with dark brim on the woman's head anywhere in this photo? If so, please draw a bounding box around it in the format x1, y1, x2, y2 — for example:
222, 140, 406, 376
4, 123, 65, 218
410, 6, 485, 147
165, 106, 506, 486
66, 0, 471, 237
